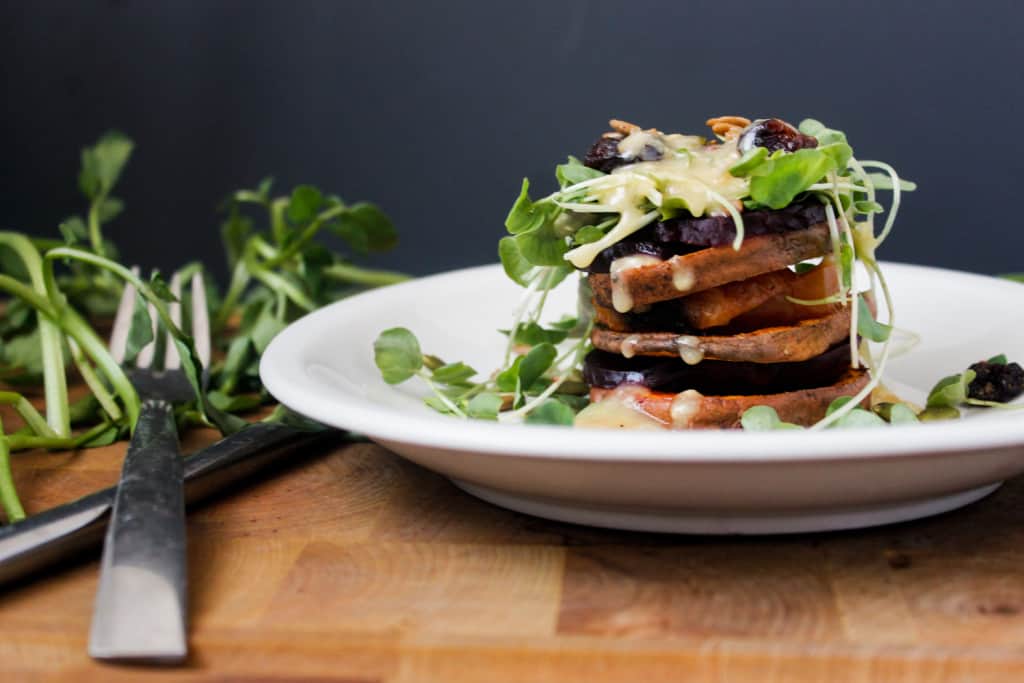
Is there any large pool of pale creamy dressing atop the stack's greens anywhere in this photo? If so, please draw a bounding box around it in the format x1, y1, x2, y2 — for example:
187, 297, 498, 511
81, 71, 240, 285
565, 130, 750, 268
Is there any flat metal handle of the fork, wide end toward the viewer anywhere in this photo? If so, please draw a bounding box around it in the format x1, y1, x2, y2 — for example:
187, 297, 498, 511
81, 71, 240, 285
89, 399, 187, 663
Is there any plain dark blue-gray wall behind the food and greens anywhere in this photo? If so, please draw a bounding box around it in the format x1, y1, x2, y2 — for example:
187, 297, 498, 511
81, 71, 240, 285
0, 0, 1024, 280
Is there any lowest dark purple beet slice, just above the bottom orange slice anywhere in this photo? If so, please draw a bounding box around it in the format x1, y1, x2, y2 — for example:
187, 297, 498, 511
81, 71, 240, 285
583, 344, 850, 395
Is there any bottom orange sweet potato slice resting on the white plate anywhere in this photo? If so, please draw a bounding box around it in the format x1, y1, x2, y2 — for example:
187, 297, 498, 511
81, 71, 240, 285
590, 368, 870, 429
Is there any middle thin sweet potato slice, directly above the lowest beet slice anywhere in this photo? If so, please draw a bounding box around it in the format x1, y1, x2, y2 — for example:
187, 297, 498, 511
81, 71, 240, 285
590, 306, 850, 362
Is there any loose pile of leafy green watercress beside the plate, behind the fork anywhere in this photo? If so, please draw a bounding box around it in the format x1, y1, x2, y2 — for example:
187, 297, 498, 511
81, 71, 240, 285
0, 133, 404, 521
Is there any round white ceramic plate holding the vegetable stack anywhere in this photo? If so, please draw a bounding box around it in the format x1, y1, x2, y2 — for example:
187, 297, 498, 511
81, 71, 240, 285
260, 263, 1024, 533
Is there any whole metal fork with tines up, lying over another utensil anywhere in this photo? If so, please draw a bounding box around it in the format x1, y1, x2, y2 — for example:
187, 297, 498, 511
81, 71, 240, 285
89, 269, 210, 664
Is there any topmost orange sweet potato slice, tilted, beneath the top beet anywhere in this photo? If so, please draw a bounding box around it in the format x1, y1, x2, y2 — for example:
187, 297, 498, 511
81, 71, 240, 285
589, 223, 830, 313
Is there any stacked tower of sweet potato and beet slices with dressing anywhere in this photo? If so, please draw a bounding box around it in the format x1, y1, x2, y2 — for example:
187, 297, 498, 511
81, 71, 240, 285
573, 117, 870, 429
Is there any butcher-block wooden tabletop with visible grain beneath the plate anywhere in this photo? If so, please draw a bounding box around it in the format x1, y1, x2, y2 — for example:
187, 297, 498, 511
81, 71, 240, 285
0, 421, 1024, 683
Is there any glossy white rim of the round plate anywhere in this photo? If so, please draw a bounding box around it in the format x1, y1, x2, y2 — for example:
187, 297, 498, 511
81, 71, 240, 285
259, 261, 1024, 464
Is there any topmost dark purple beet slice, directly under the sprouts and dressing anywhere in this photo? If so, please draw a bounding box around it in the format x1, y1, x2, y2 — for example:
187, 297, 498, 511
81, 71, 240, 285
587, 200, 825, 272
